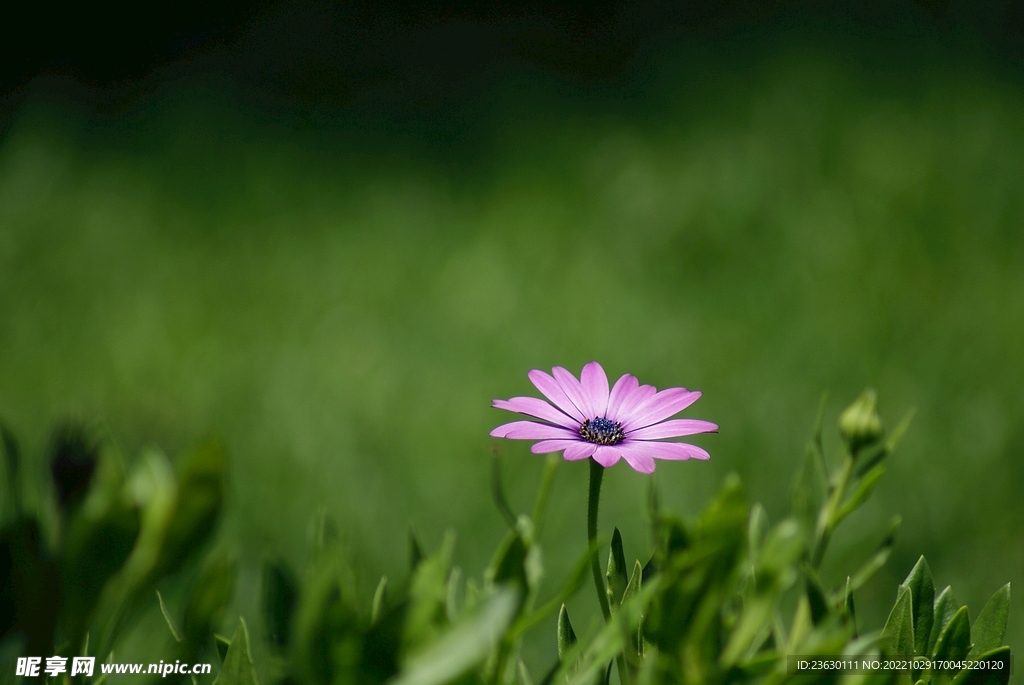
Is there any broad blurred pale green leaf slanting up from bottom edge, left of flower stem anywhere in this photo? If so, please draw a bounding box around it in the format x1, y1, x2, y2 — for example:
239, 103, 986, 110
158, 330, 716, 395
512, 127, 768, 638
390, 588, 520, 685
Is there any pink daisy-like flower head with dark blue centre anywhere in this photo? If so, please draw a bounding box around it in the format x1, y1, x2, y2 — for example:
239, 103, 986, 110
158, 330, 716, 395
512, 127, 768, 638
490, 361, 718, 473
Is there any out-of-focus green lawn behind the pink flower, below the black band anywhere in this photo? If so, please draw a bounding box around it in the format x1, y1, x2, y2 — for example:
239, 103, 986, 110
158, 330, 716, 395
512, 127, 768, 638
0, 7, 1024, 663
